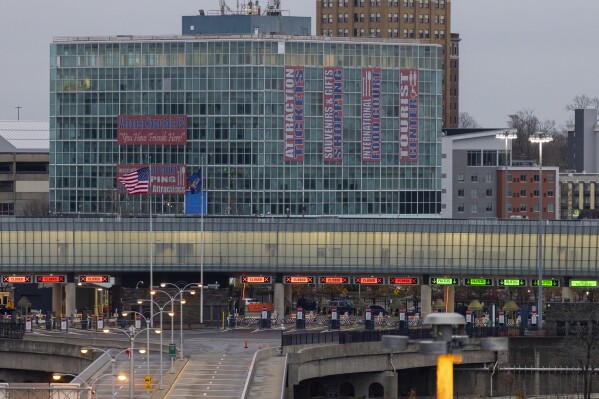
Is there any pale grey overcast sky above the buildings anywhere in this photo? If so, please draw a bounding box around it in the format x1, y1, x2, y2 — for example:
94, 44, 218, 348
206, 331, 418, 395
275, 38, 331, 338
0, 0, 599, 127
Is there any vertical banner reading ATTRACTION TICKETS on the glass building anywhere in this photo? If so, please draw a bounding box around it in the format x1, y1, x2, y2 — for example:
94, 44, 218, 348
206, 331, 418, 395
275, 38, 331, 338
284, 66, 304, 162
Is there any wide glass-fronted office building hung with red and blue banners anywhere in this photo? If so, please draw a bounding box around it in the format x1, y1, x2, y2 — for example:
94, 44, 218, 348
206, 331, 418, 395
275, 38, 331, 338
50, 35, 443, 217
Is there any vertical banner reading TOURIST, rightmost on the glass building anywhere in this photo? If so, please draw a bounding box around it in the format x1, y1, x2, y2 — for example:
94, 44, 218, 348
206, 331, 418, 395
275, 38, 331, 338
399, 68, 418, 162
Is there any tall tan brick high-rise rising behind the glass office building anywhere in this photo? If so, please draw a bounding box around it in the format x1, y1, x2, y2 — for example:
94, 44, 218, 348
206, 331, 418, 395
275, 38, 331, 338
316, 0, 460, 128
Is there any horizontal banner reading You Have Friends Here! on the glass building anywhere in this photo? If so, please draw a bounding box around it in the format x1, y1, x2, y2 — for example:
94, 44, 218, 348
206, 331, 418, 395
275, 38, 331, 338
117, 115, 187, 145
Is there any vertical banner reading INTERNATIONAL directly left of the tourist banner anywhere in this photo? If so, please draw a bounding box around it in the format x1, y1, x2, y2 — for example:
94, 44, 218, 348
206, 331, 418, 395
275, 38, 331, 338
362, 68, 382, 162
